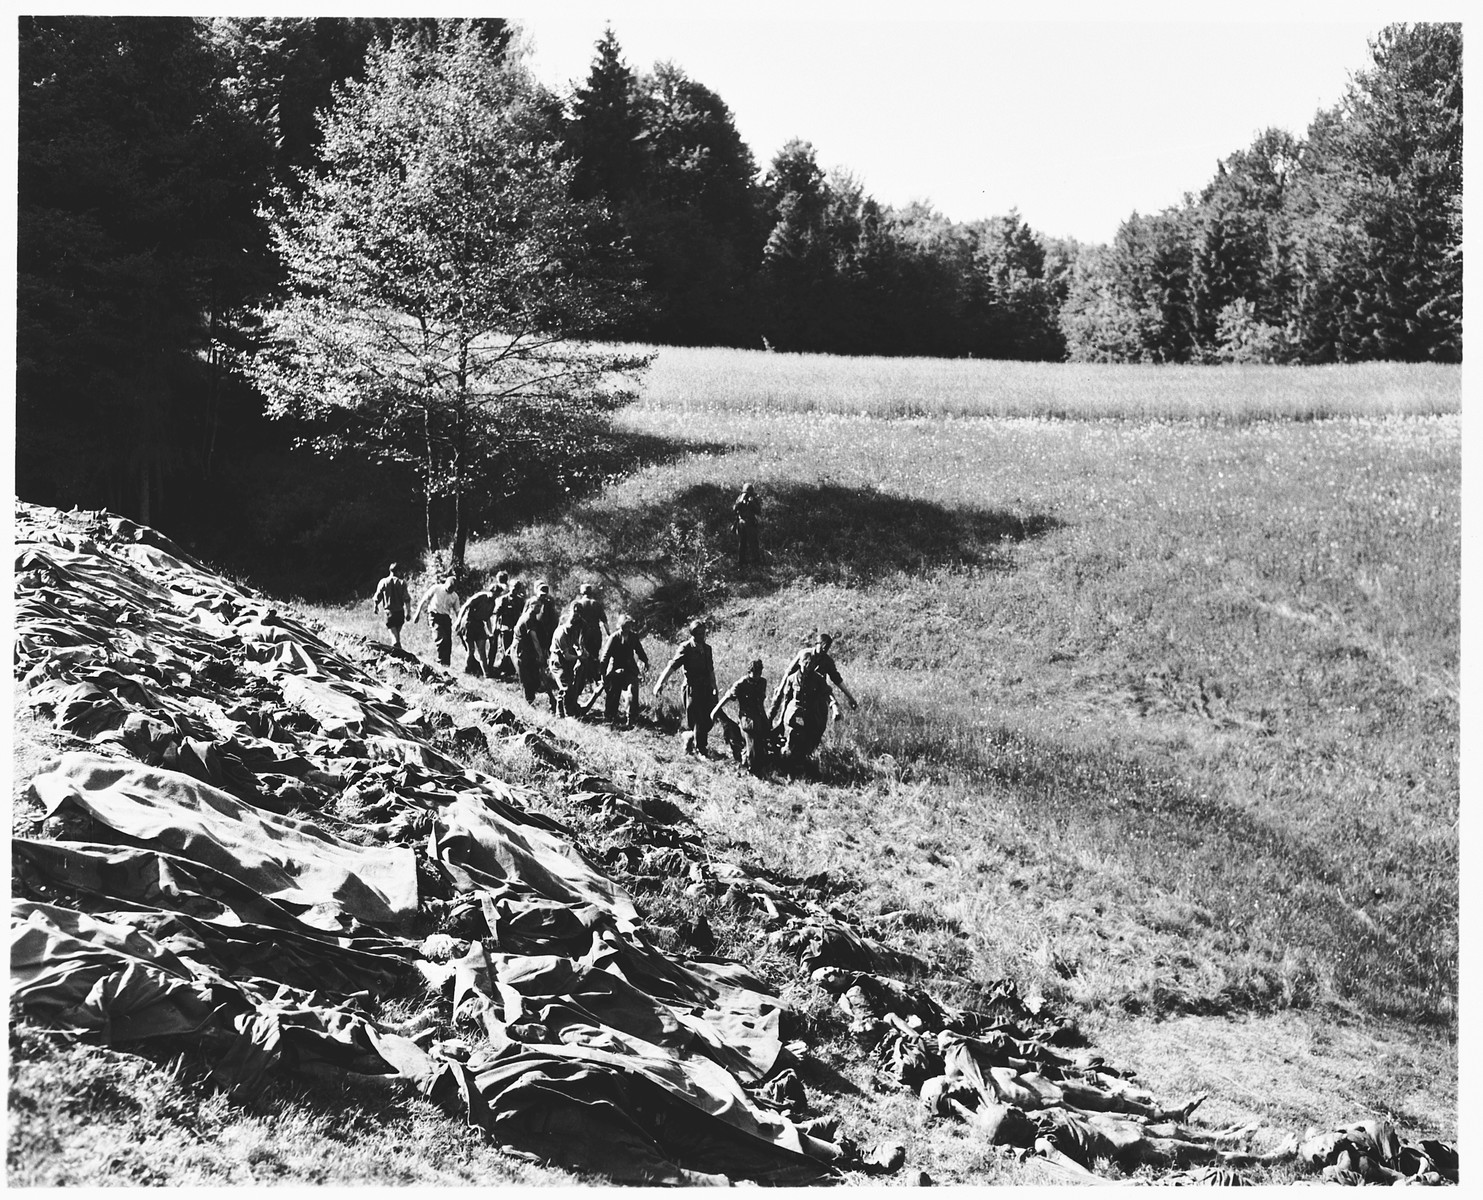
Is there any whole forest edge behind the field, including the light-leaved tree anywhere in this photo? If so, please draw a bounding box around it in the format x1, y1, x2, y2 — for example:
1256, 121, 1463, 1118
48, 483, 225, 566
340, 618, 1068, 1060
16, 16, 1462, 576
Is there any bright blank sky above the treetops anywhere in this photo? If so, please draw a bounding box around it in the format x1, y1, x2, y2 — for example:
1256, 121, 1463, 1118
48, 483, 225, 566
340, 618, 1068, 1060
516, 0, 1382, 242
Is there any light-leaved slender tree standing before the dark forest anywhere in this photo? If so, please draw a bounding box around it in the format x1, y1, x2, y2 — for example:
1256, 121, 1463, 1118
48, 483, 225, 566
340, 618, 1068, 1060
258, 24, 647, 562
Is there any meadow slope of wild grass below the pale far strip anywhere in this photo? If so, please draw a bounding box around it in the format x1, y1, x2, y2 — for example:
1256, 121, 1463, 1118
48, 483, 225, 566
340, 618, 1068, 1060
453, 379, 1461, 1026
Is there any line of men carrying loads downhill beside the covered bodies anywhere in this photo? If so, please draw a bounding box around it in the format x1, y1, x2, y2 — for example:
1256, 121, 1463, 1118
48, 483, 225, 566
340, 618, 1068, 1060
374, 562, 857, 774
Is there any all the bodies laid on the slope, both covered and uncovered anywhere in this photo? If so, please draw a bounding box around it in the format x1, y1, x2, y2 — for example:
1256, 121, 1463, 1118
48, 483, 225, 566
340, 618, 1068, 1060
10, 504, 1456, 1184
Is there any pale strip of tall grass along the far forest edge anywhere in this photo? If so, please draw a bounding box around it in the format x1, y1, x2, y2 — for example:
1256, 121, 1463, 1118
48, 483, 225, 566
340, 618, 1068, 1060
628, 347, 1461, 423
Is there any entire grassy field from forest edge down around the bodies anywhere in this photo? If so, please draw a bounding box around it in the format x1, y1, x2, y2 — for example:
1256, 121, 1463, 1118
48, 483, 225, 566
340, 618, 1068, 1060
12, 350, 1461, 1184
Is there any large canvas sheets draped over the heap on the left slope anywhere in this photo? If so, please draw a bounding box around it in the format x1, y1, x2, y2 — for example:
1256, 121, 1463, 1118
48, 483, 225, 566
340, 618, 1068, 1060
12, 506, 844, 1184
